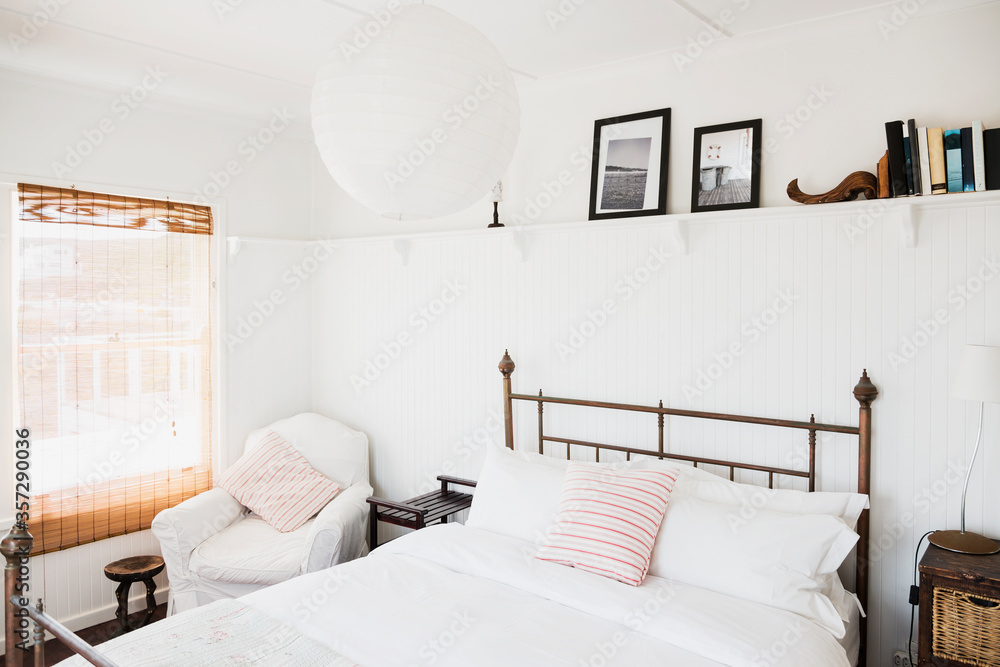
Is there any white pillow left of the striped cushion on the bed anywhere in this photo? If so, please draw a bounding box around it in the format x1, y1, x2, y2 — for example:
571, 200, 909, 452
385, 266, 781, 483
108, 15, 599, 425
465, 445, 568, 543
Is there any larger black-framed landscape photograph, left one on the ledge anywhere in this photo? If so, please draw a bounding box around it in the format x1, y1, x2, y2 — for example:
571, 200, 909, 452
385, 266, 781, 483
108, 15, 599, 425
590, 109, 670, 220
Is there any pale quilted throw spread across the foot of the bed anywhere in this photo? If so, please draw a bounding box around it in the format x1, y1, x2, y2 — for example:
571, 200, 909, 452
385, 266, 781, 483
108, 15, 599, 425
58, 600, 357, 667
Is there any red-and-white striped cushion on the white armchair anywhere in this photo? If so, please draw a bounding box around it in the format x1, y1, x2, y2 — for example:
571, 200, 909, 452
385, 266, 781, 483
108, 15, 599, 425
216, 431, 340, 533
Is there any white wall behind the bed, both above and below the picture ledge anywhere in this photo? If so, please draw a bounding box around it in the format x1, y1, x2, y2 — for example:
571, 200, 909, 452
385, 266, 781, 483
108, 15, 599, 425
312, 3, 1000, 664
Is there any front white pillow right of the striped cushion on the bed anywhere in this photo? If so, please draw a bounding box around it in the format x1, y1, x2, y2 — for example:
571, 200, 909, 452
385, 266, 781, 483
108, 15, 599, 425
649, 491, 858, 637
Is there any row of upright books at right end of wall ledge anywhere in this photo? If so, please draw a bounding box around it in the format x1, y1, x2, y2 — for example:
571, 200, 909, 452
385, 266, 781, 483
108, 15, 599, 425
878, 118, 1000, 197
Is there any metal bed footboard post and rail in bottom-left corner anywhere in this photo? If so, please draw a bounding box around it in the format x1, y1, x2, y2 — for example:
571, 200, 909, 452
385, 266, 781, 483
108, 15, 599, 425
0, 522, 117, 667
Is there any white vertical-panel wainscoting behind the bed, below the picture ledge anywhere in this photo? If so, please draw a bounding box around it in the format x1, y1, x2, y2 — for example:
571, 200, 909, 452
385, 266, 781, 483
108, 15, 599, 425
312, 195, 1000, 664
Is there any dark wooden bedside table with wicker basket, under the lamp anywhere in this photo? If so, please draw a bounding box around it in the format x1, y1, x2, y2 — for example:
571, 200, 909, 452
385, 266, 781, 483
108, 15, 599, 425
919, 544, 1000, 667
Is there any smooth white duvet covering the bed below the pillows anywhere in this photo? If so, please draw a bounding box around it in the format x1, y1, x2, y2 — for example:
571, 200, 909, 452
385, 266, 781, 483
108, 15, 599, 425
243, 524, 849, 667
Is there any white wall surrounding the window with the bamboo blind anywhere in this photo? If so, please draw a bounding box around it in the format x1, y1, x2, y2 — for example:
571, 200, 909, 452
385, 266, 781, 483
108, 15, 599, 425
0, 71, 312, 629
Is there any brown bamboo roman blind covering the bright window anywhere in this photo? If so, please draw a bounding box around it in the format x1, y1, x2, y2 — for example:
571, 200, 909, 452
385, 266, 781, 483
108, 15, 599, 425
17, 184, 212, 554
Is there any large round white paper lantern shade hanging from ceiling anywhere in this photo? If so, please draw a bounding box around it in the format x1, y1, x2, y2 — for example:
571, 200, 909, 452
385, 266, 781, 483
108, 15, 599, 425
312, 5, 521, 219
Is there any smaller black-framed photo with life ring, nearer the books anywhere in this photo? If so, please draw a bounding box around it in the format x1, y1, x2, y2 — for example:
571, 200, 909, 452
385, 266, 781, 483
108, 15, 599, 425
691, 118, 761, 213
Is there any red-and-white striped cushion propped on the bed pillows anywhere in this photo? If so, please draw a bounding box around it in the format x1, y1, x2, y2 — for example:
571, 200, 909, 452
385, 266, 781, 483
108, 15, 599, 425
536, 463, 678, 586
